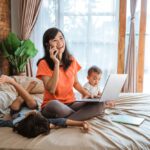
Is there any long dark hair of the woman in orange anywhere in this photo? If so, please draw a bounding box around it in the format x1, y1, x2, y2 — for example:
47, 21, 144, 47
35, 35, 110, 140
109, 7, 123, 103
37, 28, 72, 70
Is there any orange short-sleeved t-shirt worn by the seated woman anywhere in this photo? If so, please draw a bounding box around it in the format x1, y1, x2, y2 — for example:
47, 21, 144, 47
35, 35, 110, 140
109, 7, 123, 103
36, 58, 81, 108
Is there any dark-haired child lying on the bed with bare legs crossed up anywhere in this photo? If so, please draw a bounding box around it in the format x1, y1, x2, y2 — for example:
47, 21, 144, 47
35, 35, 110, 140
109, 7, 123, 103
0, 75, 89, 138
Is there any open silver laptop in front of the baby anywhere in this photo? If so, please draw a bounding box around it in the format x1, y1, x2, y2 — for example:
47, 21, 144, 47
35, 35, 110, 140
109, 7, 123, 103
76, 74, 127, 102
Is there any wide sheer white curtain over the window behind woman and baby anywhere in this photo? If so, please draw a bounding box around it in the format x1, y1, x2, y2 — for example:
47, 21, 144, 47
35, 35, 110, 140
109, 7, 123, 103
31, 0, 119, 87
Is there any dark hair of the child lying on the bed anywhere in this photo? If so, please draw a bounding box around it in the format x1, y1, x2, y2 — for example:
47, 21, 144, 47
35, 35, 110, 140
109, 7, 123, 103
13, 113, 50, 138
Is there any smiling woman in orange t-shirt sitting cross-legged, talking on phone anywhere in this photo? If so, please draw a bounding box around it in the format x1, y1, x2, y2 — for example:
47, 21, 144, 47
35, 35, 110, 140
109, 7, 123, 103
37, 28, 111, 120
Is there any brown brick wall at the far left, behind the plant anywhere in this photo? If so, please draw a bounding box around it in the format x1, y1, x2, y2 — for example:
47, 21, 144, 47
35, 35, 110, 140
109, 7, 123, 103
0, 0, 11, 75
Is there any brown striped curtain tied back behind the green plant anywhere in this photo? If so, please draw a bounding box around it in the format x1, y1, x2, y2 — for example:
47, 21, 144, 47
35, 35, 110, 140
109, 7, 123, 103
19, 0, 41, 76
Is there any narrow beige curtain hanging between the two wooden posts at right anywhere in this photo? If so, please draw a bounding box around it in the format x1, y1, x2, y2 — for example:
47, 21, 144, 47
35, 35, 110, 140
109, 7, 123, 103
123, 0, 137, 92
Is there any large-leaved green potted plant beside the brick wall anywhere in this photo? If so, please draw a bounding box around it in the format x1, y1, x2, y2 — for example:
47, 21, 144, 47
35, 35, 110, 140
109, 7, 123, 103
0, 32, 38, 74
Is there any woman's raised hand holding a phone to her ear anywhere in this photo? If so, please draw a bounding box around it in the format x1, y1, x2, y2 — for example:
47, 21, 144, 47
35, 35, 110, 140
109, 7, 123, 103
49, 46, 60, 64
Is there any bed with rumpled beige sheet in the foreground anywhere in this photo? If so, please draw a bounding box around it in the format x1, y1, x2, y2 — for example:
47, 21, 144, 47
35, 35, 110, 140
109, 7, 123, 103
0, 77, 150, 150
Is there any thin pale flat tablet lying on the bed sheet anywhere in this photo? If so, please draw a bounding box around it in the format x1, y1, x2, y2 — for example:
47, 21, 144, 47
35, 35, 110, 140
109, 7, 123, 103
110, 115, 144, 126
